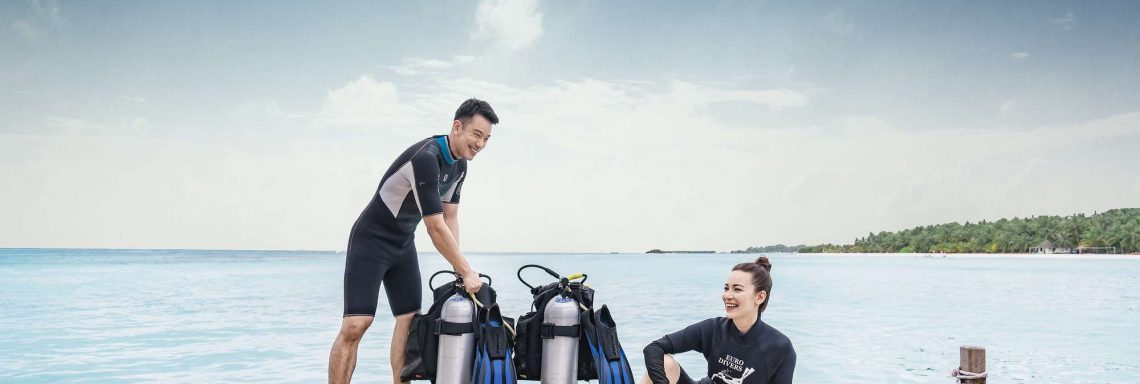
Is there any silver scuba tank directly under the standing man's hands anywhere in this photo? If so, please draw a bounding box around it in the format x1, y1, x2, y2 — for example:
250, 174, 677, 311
435, 294, 478, 384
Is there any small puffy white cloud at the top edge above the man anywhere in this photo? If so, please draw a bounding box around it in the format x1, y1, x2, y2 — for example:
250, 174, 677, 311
472, 0, 543, 50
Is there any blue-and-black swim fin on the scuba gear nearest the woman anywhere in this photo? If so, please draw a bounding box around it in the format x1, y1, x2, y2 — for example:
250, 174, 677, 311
581, 305, 635, 384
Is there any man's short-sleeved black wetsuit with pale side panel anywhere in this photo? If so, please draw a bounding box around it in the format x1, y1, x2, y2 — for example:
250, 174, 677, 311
344, 136, 467, 316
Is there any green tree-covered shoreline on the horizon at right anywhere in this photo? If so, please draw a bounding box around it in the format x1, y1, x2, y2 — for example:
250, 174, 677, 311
798, 209, 1140, 253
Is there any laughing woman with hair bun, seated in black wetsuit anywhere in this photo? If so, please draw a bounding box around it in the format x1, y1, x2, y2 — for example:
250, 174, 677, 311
642, 256, 796, 384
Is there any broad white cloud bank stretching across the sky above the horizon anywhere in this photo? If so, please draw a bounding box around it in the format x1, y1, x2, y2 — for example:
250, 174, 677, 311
0, 75, 1140, 252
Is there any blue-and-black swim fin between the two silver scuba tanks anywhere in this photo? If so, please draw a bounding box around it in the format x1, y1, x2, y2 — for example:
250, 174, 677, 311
471, 304, 519, 384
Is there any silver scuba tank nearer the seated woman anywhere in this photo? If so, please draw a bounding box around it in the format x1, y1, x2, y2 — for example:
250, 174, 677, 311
542, 295, 579, 384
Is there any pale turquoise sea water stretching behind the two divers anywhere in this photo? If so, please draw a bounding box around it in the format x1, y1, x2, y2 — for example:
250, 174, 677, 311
0, 250, 1140, 384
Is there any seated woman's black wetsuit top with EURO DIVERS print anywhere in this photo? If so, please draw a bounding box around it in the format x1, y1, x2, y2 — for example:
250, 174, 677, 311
644, 318, 796, 384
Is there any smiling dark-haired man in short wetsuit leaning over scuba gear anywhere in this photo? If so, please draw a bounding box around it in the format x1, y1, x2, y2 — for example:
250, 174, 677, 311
328, 99, 498, 383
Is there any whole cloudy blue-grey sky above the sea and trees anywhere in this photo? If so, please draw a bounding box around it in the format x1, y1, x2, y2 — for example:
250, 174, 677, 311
0, 0, 1140, 252
